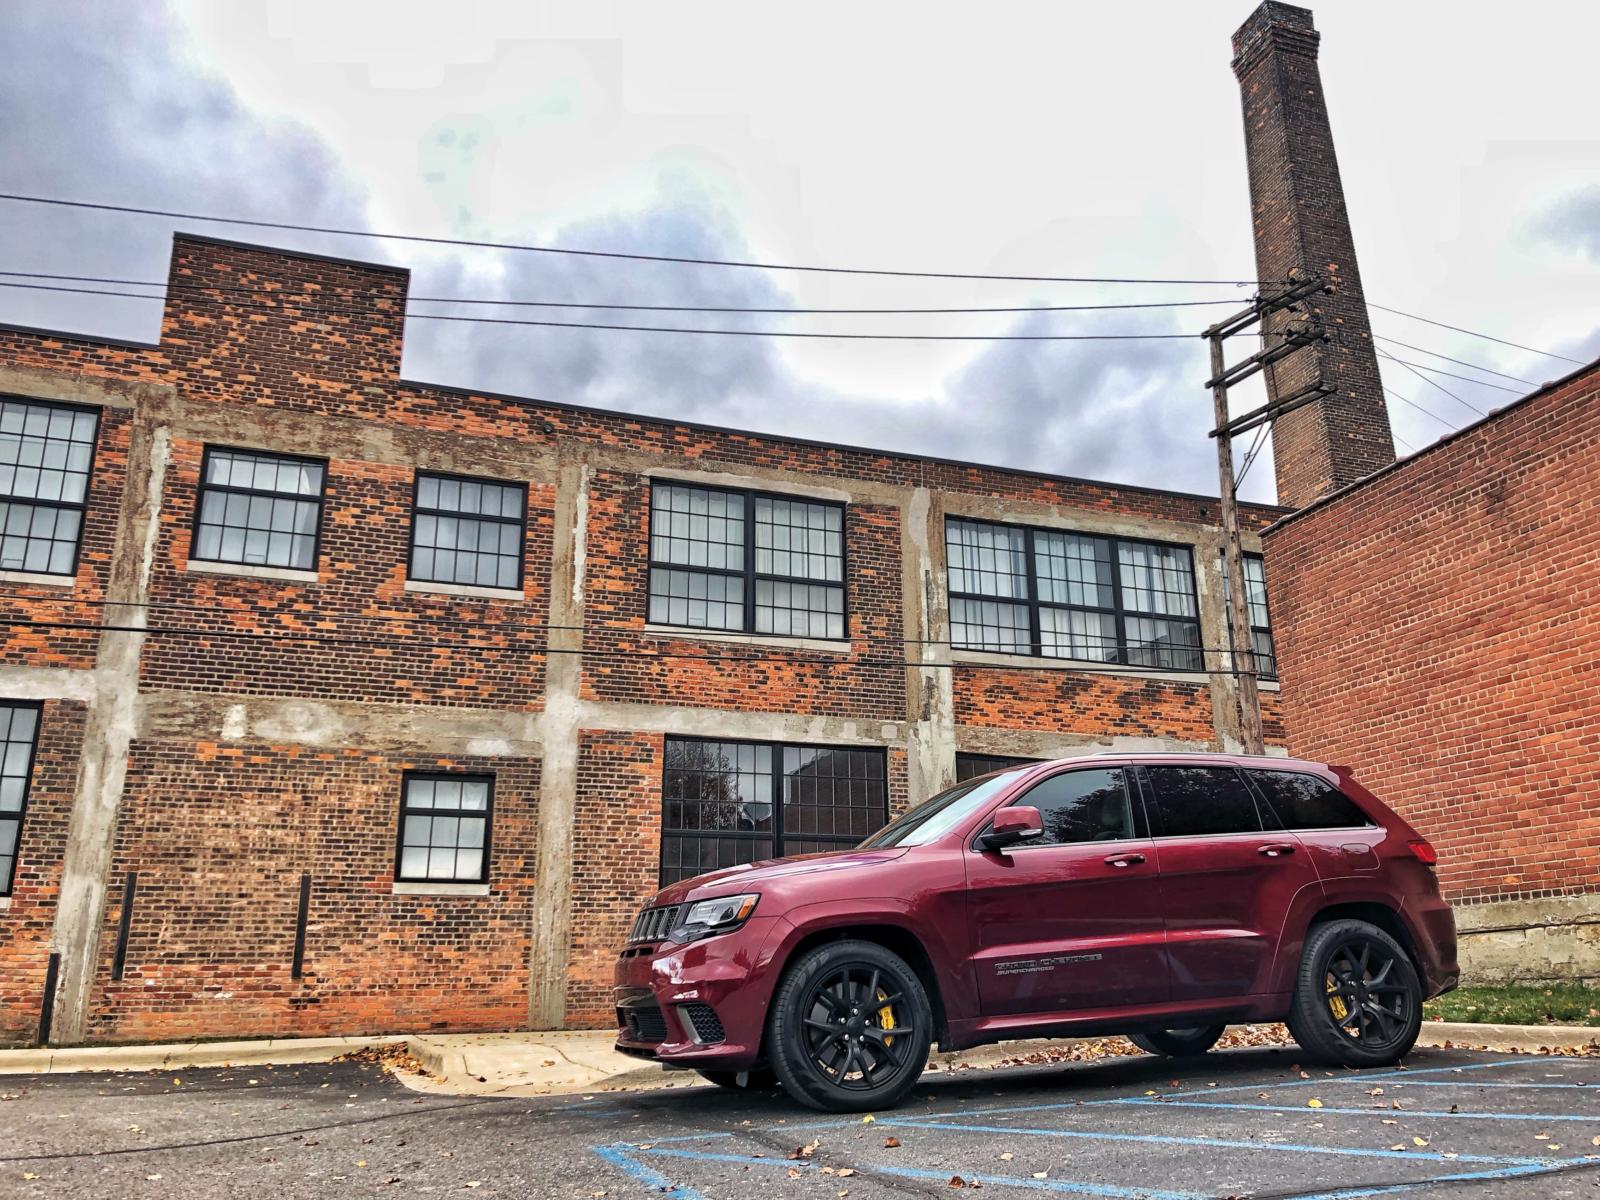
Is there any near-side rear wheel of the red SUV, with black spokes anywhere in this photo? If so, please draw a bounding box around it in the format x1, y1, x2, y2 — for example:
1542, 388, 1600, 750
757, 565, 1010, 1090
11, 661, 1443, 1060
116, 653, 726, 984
1288, 920, 1422, 1067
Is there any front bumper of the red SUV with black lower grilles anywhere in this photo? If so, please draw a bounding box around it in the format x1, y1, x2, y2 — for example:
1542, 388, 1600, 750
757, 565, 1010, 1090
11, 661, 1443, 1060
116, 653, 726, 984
613, 917, 774, 1070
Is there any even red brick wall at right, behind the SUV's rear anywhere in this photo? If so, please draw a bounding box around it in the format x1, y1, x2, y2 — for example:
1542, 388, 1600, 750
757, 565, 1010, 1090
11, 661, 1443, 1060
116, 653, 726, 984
1266, 368, 1600, 899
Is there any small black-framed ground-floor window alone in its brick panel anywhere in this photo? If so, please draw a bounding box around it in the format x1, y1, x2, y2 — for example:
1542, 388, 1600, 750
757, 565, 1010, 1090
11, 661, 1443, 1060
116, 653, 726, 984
395, 773, 494, 883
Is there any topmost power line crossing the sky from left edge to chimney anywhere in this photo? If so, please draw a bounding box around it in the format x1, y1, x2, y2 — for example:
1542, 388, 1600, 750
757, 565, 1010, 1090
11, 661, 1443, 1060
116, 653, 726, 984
0, 192, 1262, 286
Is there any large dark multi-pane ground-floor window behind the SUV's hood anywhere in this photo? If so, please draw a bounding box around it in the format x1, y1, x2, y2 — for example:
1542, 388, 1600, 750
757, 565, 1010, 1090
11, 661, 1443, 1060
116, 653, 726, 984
661, 738, 888, 886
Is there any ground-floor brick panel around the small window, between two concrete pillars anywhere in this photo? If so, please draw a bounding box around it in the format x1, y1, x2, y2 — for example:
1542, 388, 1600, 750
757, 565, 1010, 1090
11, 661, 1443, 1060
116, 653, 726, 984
86, 741, 539, 1040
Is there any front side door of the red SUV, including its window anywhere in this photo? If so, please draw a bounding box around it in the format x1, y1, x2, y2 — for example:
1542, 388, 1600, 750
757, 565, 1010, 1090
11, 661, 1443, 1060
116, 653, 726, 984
966, 765, 1168, 1016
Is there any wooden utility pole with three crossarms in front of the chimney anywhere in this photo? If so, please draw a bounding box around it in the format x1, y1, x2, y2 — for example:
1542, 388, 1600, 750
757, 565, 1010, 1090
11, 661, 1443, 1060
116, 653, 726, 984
1202, 280, 1333, 754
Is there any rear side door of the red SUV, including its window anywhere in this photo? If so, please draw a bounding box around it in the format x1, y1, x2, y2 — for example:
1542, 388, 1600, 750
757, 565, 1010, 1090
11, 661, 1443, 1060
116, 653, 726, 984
1139, 763, 1318, 1000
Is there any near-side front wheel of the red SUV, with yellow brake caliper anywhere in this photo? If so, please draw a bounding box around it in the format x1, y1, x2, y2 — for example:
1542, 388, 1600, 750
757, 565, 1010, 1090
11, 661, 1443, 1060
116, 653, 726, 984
766, 941, 933, 1112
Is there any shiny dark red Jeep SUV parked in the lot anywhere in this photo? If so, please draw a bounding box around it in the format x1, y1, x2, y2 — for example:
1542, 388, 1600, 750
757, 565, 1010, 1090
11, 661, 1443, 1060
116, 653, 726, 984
604, 754, 1458, 1112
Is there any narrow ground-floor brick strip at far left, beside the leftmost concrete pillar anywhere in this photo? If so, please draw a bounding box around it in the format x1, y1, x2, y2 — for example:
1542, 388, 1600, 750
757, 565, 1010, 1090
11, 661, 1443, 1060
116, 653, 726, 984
0, 701, 86, 1045
